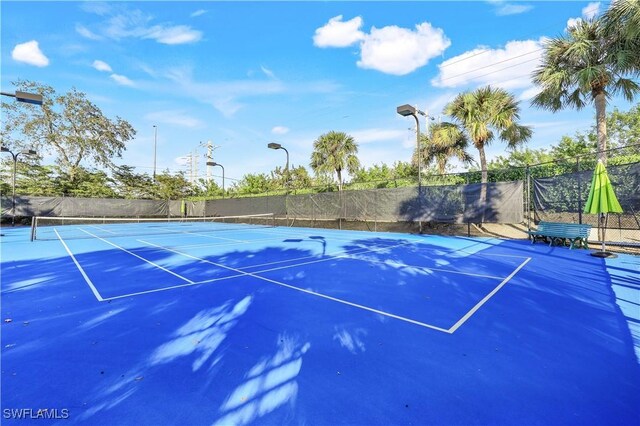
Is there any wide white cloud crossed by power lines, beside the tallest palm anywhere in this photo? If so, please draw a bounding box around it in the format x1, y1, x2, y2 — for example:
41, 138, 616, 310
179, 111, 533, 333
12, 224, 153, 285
431, 39, 543, 89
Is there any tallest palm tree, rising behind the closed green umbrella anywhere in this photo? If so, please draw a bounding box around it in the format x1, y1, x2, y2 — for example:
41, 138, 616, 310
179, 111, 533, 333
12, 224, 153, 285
532, 19, 640, 162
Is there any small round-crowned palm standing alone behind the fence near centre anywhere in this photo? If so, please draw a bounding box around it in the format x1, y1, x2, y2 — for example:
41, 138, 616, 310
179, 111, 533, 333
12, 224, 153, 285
310, 131, 360, 191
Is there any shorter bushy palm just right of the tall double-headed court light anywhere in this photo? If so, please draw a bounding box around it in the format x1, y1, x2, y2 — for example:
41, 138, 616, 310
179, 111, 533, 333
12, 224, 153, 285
412, 123, 473, 174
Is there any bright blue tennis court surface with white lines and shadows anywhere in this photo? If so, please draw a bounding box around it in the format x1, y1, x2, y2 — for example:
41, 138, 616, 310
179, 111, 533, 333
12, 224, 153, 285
1, 224, 640, 425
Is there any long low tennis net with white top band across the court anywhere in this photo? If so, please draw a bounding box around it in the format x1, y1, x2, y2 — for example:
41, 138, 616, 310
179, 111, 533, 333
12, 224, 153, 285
31, 213, 276, 241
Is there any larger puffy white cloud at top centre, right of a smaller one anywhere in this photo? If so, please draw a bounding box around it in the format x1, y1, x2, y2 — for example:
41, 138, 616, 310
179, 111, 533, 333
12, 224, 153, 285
358, 22, 451, 75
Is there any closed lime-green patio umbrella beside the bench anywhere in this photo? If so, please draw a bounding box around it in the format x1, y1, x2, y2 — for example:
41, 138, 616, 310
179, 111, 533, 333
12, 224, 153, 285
584, 160, 622, 257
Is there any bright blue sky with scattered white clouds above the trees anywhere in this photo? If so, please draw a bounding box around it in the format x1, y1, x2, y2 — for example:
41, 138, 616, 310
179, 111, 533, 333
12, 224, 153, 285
1, 1, 628, 186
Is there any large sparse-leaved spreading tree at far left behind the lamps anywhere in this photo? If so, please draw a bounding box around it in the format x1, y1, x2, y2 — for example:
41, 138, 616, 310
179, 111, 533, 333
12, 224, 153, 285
0, 80, 136, 184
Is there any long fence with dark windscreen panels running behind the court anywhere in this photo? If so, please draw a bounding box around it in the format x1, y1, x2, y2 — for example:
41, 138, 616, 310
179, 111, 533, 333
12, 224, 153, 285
5, 145, 640, 249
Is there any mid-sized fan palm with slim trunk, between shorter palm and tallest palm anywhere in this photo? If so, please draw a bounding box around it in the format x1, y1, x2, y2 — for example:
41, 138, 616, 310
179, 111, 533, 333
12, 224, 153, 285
444, 86, 532, 183
